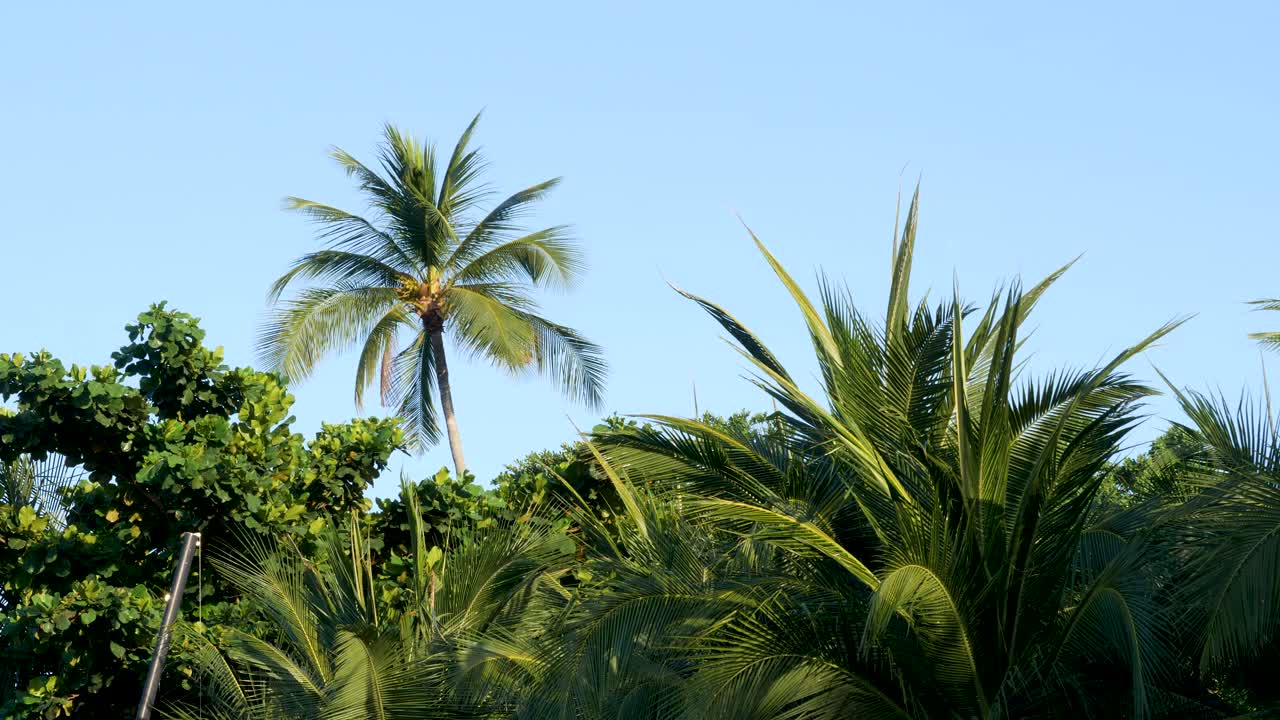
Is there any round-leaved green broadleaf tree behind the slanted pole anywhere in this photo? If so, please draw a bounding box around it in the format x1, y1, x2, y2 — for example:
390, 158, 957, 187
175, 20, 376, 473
0, 305, 401, 717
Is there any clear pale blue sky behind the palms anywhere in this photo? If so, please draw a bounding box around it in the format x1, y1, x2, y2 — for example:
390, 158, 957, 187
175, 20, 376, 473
0, 1, 1280, 492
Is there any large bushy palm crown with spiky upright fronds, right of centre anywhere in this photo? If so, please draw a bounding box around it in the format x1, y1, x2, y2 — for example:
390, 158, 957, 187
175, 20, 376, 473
600, 188, 1176, 719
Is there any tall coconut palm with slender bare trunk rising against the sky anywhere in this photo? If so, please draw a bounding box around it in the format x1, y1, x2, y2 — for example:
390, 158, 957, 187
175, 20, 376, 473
259, 115, 605, 477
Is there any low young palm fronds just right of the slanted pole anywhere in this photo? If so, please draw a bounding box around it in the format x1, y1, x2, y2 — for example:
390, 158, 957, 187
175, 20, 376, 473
168, 484, 572, 720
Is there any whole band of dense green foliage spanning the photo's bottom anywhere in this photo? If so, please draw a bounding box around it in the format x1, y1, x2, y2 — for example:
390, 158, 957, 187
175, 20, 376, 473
0, 188, 1280, 720
